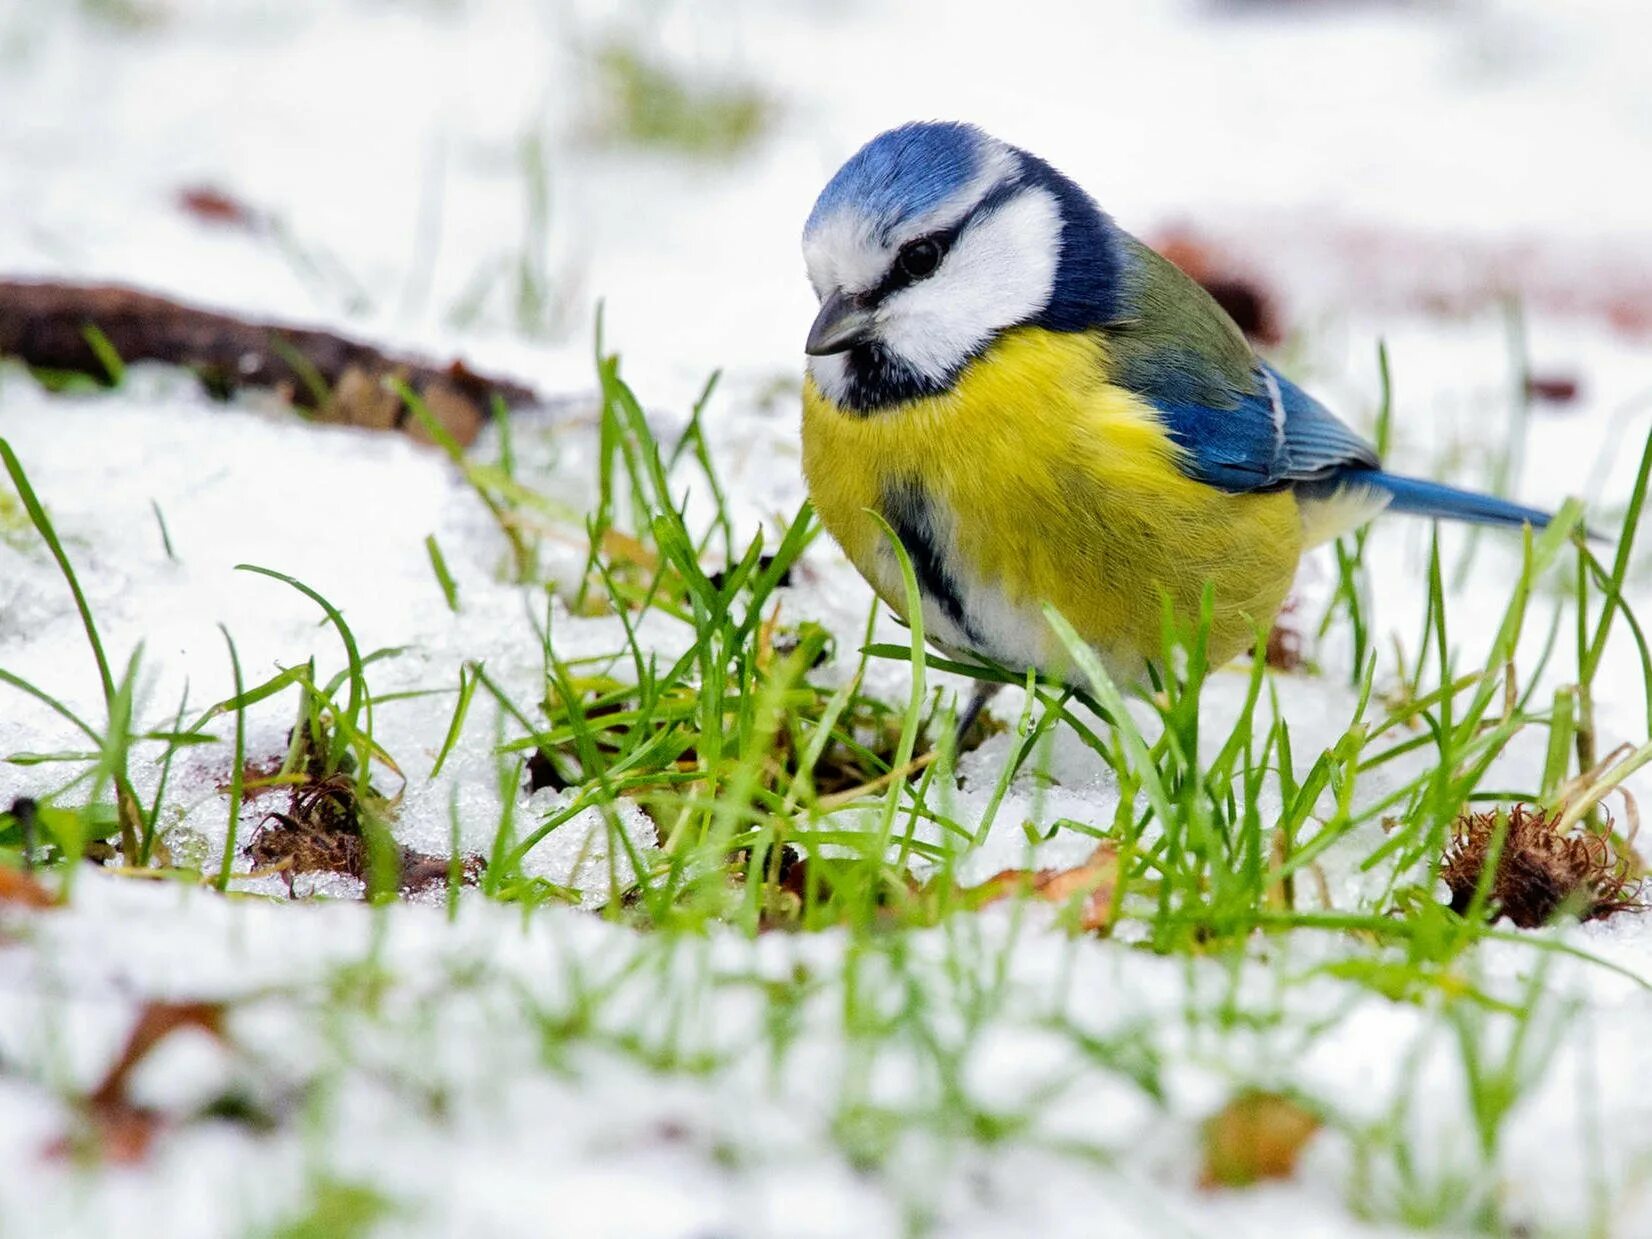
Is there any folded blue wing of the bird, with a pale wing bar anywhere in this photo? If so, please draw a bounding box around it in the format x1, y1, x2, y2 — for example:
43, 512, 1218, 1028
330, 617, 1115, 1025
1148, 362, 1381, 491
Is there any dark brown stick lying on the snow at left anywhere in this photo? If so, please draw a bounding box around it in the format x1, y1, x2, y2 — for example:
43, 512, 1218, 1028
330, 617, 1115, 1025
0, 279, 539, 444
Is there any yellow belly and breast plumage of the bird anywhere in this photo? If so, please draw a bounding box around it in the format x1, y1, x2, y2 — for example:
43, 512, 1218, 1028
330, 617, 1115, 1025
803, 327, 1302, 677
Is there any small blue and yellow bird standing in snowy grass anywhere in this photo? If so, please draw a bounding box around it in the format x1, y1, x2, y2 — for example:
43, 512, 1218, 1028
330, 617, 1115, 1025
801, 121, 1550, 717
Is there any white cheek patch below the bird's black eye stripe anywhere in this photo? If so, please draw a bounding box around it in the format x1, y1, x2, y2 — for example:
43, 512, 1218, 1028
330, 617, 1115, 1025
877, 190, 1061, 382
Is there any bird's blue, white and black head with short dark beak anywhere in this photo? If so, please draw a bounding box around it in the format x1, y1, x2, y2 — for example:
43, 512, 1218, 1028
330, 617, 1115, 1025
803, 122, 1117, 413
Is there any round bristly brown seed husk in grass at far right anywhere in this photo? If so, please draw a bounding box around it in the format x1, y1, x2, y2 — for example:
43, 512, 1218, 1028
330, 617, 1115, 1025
1441, 805, 1642, 928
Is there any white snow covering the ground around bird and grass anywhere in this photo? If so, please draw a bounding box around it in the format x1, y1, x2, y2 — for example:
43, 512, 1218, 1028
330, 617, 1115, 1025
0, 0, 1652, 1236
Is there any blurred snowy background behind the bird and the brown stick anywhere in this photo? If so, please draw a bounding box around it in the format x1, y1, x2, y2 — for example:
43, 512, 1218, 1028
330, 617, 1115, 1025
0, 0, 1652, 417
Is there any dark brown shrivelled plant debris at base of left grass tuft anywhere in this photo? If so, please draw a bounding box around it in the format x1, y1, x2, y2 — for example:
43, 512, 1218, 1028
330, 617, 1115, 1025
246, 775, 486, 894
